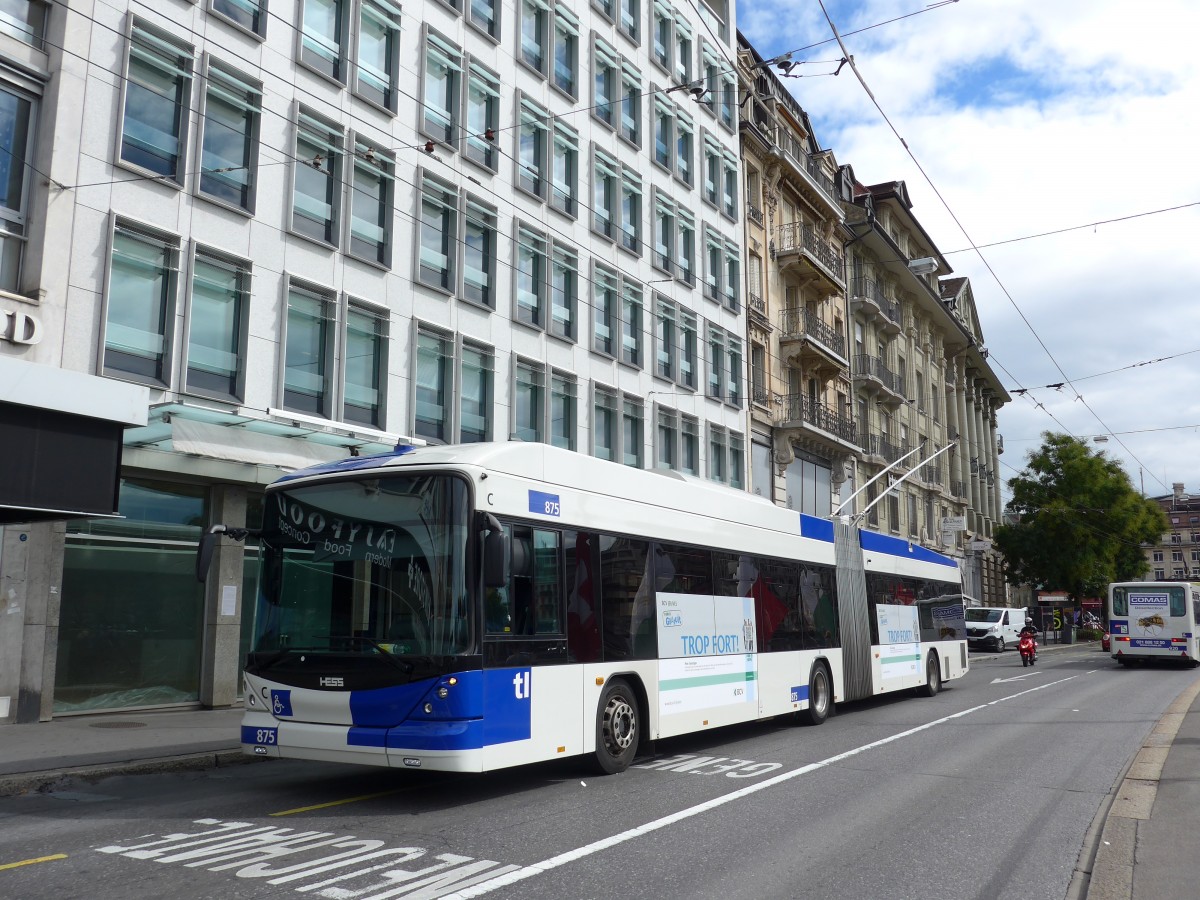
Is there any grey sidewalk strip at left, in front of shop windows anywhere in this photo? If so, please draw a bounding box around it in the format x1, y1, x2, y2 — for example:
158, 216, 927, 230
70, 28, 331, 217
0, 706, 252, 797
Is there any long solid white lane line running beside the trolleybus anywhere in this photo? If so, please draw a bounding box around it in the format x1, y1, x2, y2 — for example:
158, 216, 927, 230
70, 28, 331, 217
443, 676, 1079, 900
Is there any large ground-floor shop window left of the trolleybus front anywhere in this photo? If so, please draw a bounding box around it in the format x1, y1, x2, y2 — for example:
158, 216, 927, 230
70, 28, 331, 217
54, 479, 208, 713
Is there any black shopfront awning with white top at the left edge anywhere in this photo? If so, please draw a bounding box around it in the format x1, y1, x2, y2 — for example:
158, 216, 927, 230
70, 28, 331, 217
0, 356, 149, 524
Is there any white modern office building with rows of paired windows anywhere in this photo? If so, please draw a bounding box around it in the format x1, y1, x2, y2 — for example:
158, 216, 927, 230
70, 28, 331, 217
0, 0, 749, 721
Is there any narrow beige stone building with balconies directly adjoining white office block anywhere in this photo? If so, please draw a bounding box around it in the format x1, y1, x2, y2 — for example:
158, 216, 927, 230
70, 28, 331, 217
738, 38, 859, 516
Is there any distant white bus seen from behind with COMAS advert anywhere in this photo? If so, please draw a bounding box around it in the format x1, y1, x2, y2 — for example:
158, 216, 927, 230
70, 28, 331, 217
1109, 581, 1200, 666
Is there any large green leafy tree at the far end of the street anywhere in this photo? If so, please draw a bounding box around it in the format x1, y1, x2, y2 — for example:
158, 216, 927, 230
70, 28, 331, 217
996, 432, 1168, 601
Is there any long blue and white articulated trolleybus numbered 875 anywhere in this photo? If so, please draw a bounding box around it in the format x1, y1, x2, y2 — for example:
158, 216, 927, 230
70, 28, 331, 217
206, 442, 967, 773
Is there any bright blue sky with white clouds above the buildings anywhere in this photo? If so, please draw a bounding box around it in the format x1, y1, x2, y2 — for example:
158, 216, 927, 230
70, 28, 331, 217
738, 0, 1200, 496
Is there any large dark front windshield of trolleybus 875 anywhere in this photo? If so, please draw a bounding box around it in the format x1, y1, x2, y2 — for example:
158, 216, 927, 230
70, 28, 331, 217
252, 474, 474, 656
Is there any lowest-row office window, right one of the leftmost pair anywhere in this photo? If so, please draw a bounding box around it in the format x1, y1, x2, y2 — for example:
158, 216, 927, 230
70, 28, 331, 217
187, 250, 250, 398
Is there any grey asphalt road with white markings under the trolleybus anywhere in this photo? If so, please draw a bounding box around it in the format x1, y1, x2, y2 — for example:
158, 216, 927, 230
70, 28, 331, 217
0, 646, 1195, 900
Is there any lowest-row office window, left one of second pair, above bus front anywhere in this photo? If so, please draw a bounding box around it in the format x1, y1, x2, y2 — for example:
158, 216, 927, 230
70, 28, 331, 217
283, 286, 334, 415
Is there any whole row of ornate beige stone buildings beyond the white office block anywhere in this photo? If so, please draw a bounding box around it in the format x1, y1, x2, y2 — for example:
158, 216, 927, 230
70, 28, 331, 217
738, 35, 1009, 605
